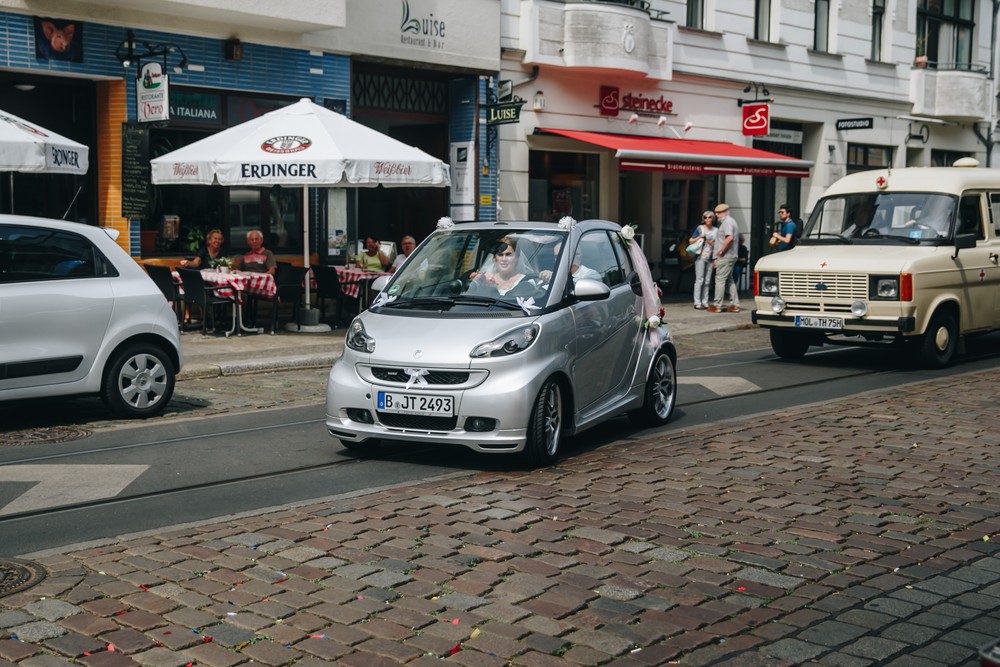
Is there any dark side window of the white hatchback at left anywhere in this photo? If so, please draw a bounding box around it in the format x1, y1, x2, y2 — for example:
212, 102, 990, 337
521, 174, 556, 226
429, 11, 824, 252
0, 225, 106, 283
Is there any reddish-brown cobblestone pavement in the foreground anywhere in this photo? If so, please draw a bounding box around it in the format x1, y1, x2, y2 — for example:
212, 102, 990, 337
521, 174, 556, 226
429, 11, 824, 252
0, 342, 1000, 667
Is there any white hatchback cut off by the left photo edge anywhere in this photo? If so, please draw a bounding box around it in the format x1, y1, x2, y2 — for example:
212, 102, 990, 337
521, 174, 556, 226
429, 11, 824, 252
0, 215, 182, 418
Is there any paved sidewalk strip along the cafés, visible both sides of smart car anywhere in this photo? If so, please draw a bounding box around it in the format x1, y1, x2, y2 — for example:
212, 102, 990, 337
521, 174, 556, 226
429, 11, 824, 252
180, 295, 753, 380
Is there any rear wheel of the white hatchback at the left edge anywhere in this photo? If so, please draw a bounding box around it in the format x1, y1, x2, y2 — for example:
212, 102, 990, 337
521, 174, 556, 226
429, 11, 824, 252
101, 343, 177, 419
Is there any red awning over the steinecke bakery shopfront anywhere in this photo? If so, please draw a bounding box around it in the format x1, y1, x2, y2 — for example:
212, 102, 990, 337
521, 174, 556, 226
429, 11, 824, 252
538, 128, 813, 178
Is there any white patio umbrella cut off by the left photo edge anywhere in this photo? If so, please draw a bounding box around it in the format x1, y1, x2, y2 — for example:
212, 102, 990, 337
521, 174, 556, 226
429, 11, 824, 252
0, 111, 90, 211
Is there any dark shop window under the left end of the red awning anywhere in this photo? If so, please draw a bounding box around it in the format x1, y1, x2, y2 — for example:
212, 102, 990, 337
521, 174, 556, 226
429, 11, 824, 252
528, 151, 600, 222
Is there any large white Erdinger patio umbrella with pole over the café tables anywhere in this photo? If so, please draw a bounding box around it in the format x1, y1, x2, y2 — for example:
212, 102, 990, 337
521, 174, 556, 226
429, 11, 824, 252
150, 98, 451, 318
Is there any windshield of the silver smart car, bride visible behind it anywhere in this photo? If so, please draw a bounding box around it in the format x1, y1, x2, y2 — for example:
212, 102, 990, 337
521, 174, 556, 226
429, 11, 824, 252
373, 225, 566, 315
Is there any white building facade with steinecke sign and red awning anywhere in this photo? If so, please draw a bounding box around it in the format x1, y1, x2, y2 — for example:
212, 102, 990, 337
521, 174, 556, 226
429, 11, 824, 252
499, 0, 998, 280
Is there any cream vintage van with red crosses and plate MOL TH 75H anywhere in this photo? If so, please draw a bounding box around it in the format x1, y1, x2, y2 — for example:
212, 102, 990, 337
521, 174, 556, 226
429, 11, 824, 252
753, 158, 1000, 368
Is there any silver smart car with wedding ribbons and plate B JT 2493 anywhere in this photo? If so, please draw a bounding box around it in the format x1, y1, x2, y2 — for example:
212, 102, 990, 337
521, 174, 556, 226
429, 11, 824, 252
326, 218, 677, 465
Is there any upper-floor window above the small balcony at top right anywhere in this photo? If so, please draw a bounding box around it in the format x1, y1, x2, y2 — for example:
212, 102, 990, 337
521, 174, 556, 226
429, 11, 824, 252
916, 0, 976, 69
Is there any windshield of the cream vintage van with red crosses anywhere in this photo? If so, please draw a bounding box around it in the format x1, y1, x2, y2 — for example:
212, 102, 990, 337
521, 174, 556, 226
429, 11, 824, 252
802, 192, 957, 244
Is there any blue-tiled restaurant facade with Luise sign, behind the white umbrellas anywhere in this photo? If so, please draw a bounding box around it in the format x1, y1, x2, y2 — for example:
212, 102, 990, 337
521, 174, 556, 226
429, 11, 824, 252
0, 0, 500, 262
